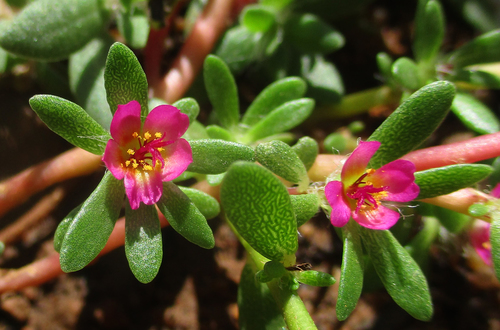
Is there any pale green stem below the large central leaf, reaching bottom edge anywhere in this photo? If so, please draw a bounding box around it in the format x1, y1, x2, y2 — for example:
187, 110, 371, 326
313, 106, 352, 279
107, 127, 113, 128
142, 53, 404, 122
226, 218, 317, 330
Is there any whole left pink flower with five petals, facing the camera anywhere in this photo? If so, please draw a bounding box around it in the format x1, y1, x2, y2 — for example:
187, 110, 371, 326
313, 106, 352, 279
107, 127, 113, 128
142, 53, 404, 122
102, 101, 193, 209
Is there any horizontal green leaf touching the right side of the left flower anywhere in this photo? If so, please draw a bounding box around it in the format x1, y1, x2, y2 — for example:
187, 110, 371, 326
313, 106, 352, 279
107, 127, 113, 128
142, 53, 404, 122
188, 140, 255, 174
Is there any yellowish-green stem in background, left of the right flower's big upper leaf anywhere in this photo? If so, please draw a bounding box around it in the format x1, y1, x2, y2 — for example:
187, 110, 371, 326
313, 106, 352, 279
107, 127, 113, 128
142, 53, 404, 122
312, 85, 401, 120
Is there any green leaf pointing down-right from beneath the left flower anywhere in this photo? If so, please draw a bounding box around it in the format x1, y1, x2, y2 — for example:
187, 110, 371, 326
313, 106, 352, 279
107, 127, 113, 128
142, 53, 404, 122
156, 182, 215, 249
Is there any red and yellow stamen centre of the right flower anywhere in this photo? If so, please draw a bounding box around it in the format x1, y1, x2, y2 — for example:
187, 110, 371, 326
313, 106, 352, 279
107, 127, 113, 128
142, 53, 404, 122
346, 169, 387, 214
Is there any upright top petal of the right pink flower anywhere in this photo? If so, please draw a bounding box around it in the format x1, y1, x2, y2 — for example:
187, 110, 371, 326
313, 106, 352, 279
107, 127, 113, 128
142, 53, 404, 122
340, 141, 380, 187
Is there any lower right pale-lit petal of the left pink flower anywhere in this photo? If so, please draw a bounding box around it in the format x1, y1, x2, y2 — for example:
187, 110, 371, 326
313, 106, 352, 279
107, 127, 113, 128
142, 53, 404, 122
162, 139, 193, 181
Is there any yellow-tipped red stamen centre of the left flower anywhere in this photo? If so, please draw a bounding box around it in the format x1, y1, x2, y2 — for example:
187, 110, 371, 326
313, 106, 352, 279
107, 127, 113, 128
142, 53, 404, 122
121, 131, 172, 171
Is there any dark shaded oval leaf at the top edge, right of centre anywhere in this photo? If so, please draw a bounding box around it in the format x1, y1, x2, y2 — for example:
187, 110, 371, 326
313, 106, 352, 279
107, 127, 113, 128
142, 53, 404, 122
285, 13, 345, 54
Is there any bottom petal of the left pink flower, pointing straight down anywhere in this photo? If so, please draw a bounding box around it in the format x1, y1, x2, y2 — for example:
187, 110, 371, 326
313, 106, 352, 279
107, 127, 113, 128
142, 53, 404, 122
124, 170, 163, 210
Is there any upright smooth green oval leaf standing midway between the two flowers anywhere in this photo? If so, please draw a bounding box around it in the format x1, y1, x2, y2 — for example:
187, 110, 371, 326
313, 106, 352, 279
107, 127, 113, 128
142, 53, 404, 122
203, 55, 240, 130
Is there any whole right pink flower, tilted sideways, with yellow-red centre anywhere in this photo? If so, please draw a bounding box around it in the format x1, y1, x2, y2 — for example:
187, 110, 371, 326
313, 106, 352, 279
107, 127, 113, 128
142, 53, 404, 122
325, 141, 420, 230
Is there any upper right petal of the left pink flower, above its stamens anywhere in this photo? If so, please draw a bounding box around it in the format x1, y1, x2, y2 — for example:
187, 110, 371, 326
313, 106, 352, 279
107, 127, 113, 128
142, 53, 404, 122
143, 105, 189, 141
